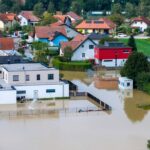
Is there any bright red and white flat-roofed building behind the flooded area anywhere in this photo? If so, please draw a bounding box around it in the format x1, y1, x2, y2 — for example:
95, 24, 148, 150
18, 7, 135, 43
95, 42, 132, 67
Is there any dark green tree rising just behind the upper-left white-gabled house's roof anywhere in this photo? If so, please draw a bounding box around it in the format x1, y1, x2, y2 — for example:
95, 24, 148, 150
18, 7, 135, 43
33, 3, 44, 17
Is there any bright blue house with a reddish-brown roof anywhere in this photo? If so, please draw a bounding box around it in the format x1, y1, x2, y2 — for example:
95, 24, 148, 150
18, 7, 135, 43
34, 26, 68, 46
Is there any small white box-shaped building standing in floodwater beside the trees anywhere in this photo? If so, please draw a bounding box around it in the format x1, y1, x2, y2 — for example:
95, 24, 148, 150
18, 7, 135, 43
118, 77, 133, 90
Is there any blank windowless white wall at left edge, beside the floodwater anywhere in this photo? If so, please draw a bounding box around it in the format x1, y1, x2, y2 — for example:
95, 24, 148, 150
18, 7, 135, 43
0, 90, 17, 104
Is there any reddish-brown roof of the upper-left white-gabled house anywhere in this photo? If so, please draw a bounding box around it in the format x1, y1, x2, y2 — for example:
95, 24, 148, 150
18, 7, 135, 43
20, 11, 40, 22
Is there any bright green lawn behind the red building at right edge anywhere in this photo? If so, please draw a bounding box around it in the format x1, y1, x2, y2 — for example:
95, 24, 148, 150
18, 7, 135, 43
119, 39, 150, 56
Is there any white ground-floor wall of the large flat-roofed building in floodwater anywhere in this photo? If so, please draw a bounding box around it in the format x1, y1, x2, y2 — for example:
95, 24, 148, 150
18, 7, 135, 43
15, 83, 69, 99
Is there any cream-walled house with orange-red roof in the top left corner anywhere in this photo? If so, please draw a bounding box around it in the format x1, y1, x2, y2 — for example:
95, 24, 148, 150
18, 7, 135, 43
0, 13, 18, 31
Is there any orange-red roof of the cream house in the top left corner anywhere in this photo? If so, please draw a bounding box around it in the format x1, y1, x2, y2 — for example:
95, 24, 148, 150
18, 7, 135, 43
0, 13, 16, 21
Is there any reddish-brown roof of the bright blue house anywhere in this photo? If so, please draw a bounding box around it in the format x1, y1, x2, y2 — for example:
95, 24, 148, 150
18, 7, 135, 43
35, 26, 66, 40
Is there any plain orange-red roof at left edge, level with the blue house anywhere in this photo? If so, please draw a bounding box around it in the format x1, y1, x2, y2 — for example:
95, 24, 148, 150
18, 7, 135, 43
0, 38, 15, 50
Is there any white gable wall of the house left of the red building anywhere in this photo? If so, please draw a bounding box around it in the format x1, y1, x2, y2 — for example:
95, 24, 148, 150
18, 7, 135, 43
71, 40, 95, 61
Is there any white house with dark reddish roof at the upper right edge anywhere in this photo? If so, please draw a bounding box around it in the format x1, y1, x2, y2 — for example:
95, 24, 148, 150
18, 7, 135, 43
131, 17, 150, 32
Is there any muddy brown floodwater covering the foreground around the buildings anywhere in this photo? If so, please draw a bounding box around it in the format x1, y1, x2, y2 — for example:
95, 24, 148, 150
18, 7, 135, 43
0, 70, 150, 150
